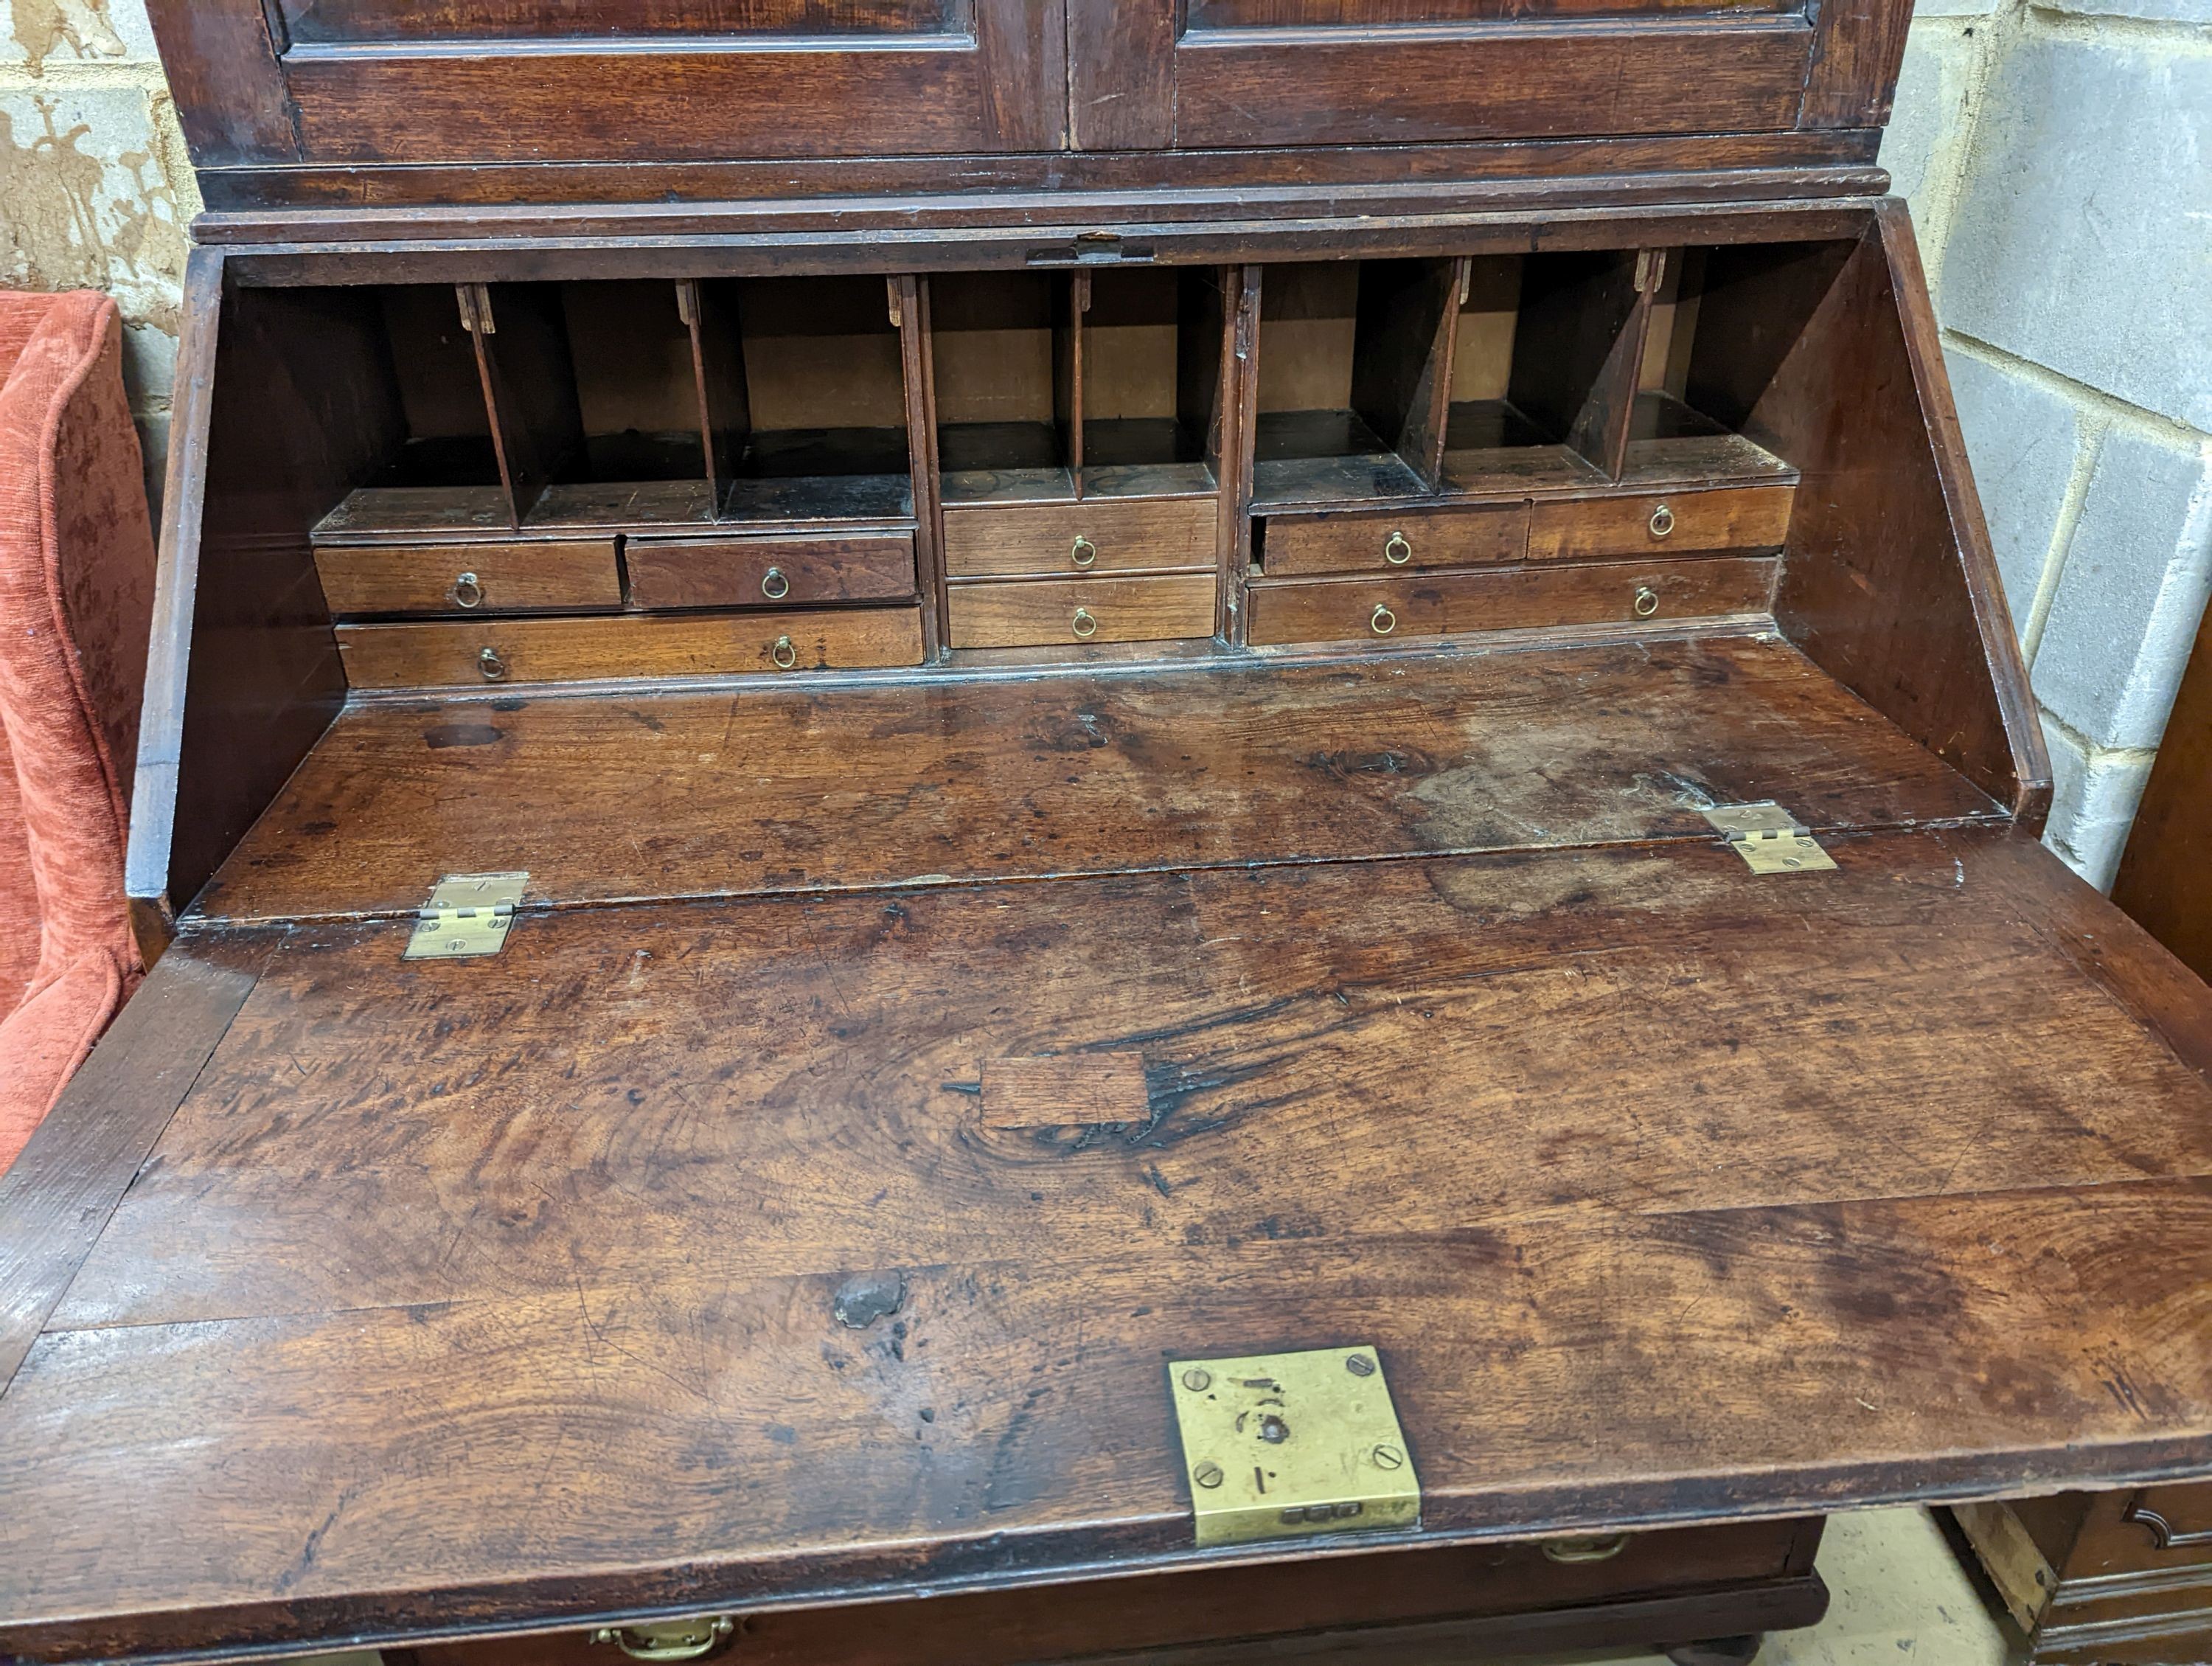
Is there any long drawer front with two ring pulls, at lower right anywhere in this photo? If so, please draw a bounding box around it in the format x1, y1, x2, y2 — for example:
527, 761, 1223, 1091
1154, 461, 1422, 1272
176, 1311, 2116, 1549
1248, 555, 1778, 644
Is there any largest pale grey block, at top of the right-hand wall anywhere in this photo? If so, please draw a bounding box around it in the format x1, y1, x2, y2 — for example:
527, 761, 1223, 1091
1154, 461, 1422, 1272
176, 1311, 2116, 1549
1942, 38, 2212, 429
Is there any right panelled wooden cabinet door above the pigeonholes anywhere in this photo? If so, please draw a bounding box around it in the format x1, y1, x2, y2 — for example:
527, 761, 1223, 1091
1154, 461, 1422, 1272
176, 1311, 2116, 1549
1066, 0, 1858, 150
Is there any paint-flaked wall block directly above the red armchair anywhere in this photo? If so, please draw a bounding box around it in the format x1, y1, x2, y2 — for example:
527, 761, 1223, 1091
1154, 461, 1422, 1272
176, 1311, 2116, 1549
0, 84, 186, 336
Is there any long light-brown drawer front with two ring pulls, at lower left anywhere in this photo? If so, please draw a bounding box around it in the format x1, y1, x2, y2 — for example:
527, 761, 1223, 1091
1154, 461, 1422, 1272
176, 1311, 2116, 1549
338, 608, 922, 688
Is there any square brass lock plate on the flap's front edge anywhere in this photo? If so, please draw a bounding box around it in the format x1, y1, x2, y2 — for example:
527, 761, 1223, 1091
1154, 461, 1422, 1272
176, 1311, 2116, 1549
1168, 1347, 1420, 1549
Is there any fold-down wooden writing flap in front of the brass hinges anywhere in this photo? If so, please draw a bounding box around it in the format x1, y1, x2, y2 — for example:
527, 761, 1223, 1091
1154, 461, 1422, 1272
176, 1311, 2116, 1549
0, 827, 2212, 1655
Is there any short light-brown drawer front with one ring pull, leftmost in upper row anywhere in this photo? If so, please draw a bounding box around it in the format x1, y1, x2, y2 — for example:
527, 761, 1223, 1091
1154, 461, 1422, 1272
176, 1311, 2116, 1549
314, 538, 622, 615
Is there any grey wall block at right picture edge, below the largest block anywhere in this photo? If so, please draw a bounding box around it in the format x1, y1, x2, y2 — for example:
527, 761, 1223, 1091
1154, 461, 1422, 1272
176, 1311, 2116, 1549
2033, 429, 2212, 748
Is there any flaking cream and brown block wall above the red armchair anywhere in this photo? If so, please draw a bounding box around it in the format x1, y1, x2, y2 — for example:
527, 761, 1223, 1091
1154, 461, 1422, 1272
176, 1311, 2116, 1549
0, 0, 199, 513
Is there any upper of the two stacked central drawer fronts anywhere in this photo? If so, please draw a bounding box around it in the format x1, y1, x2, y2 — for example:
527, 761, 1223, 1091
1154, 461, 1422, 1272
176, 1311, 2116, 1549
945, 498, 1214, 580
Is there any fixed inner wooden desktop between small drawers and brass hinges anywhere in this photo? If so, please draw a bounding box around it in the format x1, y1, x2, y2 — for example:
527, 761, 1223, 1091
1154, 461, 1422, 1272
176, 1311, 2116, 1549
186, 639, 1995, 920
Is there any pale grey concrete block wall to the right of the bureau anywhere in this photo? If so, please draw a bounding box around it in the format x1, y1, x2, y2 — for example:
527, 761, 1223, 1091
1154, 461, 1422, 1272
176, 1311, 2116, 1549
1882, 0, 2212, 887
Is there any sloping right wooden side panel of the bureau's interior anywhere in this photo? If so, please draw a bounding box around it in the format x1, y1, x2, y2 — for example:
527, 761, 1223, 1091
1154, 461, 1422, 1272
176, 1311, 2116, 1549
1717, 215, 2051, 827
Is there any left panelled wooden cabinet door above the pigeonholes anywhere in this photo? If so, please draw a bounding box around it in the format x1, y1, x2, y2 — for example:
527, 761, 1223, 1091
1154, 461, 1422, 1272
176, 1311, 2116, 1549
150, 0, 1066, 166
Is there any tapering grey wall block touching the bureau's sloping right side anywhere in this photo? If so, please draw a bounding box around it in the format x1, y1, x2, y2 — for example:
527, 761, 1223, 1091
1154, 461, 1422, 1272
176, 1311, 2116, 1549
1947, 347, 2079, 631
